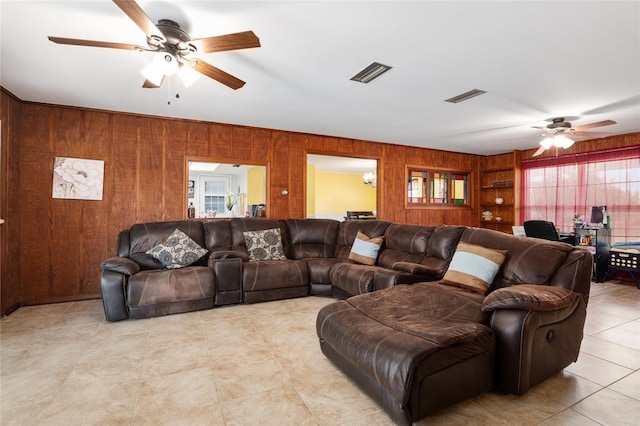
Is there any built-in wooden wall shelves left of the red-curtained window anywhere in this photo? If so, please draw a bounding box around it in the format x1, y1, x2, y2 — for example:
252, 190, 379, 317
479, 150, 522, 234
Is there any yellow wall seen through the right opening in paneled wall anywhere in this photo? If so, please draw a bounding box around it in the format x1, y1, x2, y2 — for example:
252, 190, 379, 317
308, 172, 376, 216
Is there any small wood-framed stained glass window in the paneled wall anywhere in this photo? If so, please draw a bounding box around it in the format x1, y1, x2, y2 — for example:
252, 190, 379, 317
407, 168, 469, 206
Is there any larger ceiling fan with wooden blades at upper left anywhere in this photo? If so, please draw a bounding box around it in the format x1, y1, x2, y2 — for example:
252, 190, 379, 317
49, 0, 260, 90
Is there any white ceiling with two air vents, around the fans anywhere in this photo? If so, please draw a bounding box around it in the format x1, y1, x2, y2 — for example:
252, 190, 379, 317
0, 0, 640, 154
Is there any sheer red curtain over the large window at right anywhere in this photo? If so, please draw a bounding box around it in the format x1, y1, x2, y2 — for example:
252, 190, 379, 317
521, 145, 640, 243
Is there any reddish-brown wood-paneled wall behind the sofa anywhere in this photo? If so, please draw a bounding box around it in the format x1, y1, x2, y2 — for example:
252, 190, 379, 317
1, 92, 479, 314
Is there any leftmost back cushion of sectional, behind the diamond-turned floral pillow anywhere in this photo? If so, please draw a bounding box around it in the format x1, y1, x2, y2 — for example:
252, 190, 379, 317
129, 220, 208, 270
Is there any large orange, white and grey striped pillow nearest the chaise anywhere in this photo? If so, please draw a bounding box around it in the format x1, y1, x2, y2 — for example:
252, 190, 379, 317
440, 243, 507, 294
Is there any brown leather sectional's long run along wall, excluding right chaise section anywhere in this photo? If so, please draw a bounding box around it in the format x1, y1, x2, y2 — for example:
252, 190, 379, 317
100, 218, 464, 321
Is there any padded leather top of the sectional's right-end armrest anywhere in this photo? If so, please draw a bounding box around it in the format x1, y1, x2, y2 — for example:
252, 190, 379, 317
482, 284, 580, 312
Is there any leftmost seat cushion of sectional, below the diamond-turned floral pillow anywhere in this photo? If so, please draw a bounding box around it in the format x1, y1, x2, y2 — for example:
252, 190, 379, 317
126, 266, 215, 307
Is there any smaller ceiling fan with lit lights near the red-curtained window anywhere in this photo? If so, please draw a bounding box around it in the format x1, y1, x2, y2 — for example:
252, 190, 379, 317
531, 117, 617, 157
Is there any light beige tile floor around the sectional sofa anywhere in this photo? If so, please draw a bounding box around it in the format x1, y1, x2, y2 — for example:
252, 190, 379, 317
0, 283, 640, 426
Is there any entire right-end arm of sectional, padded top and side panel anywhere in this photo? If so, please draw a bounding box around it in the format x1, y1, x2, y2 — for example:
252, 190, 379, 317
483, 284, 587, 395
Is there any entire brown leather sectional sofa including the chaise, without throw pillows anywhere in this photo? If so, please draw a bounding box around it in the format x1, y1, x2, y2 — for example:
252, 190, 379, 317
101, 218, 592, 424
